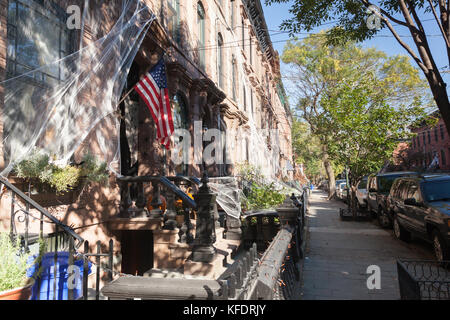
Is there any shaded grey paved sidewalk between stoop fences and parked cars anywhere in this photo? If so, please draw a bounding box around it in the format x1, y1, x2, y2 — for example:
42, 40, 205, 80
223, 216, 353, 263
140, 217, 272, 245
301, 190, 434, 300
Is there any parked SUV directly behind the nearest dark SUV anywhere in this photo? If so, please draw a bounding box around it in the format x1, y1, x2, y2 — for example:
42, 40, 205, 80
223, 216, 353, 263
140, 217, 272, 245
367, 171, 418, 228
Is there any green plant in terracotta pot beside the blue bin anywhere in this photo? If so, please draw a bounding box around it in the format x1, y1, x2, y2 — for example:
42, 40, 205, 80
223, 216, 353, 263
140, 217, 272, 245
0, 233, 34, 300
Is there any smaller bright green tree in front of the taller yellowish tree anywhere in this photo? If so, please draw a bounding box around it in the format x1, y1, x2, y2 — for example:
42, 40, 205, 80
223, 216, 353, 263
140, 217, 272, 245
321, 79, 423, 216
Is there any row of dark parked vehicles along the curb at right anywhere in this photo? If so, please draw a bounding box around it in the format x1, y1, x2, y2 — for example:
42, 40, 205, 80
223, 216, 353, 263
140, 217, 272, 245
356, 172, 450, 261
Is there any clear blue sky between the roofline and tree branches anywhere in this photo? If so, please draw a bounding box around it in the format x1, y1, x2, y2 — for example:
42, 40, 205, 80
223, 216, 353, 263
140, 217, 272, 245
261, 0, 450, 106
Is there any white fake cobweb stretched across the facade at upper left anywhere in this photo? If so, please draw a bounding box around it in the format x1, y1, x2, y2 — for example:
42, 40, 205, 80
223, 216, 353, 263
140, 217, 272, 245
0, 0, 155, 176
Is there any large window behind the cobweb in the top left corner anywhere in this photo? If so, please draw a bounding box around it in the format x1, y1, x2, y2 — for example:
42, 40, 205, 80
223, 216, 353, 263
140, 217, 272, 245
6, 0, 75, 86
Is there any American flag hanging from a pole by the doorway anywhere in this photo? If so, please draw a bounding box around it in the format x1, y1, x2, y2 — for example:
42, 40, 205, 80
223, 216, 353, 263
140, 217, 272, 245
134, 59, 174, 149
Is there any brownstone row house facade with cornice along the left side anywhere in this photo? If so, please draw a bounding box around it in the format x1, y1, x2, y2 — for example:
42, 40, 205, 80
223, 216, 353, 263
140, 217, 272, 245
0, 0, 294, 282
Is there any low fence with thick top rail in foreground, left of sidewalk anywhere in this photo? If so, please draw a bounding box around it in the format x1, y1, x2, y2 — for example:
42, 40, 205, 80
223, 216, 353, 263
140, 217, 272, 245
102, 195, 307, 300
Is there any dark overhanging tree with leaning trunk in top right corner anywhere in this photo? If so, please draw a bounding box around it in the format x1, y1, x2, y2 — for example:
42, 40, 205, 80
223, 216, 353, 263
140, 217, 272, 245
266, 0, 450, 138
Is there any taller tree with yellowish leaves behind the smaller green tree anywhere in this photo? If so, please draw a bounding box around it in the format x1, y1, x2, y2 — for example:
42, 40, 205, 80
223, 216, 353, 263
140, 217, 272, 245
282, 32, 430, 198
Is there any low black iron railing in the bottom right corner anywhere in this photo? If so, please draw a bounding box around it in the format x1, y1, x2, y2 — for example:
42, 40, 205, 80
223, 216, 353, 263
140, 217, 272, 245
397, 260, 450, 300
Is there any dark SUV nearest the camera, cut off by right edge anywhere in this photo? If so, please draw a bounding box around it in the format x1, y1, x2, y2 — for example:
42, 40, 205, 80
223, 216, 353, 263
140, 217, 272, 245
389, 175, 450, 261
